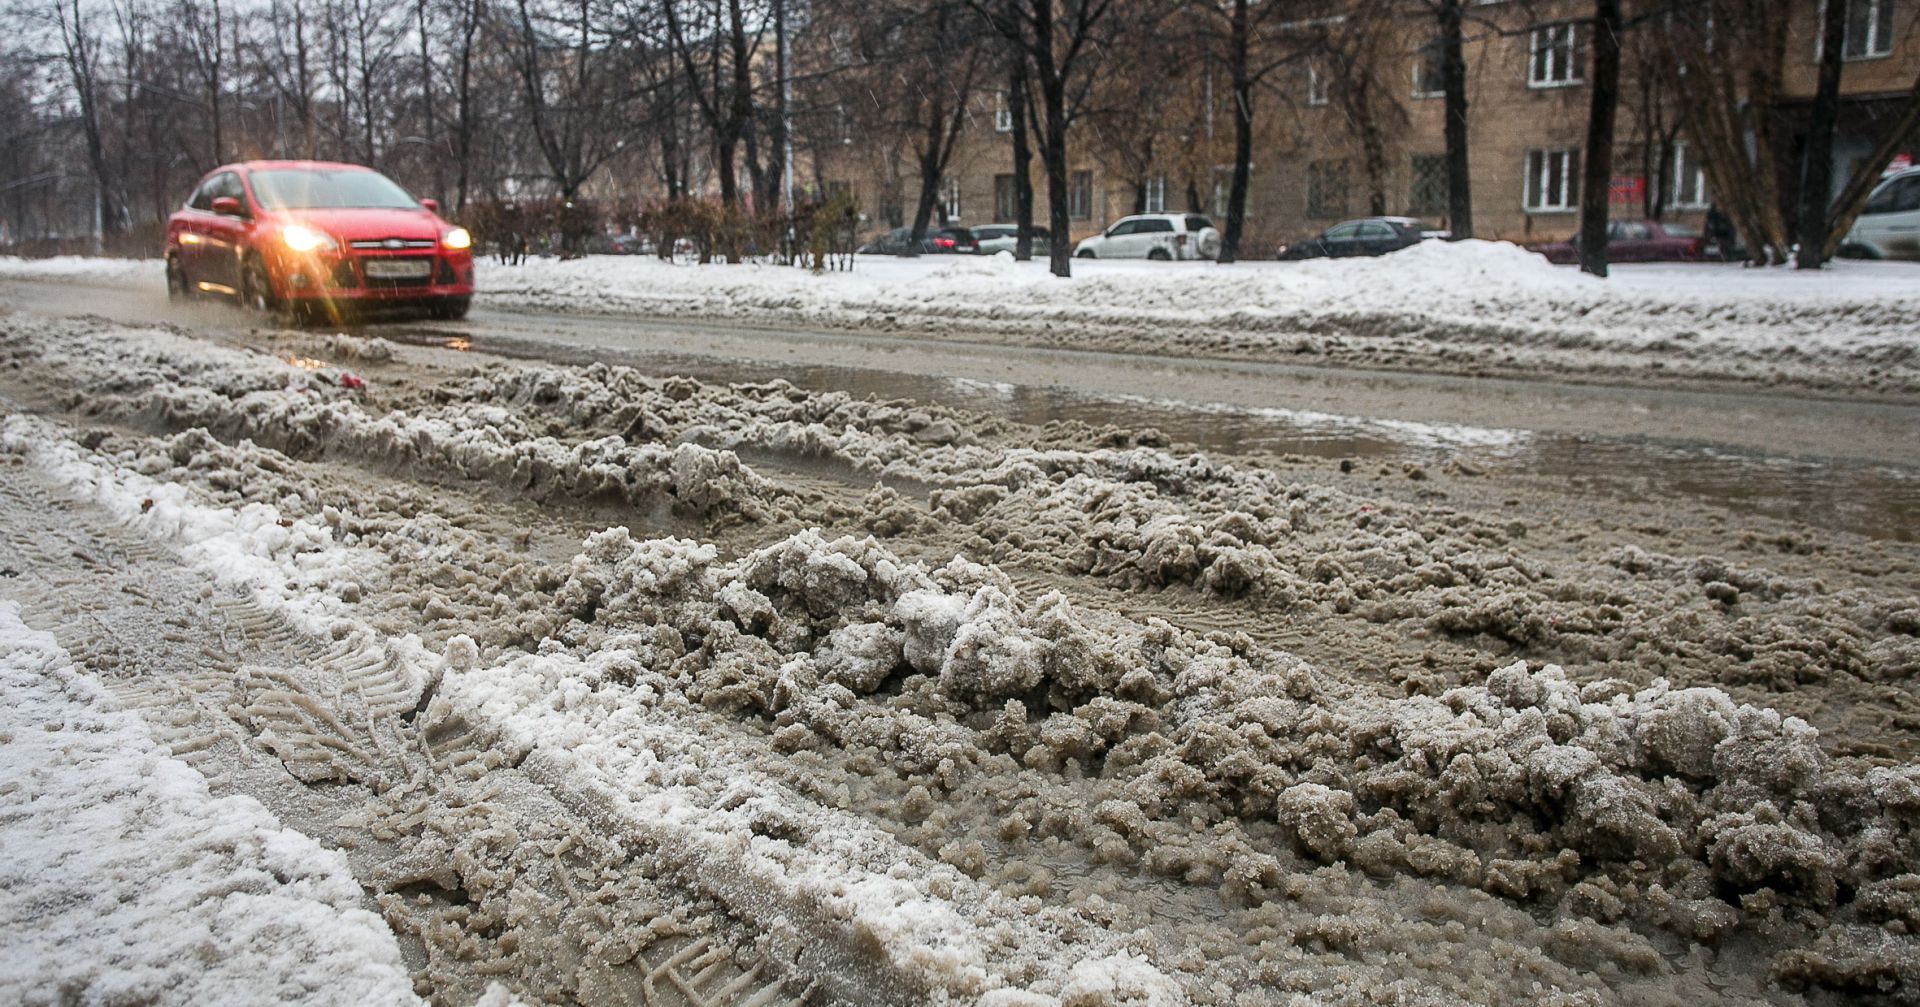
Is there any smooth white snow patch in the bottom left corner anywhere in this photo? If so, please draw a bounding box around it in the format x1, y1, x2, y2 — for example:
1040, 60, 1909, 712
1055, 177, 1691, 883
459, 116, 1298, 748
0, 603, 417, 1005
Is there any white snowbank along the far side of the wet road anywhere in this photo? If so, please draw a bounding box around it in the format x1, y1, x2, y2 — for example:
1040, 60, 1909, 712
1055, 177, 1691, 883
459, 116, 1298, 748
0, 242, 1920, 394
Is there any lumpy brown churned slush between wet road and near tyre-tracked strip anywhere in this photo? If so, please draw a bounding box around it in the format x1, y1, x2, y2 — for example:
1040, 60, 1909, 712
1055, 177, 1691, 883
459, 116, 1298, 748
0, 315, 1920, 1005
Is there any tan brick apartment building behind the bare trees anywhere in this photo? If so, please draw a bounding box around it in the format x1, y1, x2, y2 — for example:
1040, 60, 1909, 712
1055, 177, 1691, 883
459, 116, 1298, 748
812, 0, 1920, 258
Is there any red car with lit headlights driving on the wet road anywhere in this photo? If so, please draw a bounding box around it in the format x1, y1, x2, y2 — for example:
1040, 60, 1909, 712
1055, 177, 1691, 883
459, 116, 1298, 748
167, 161, 474, 319
